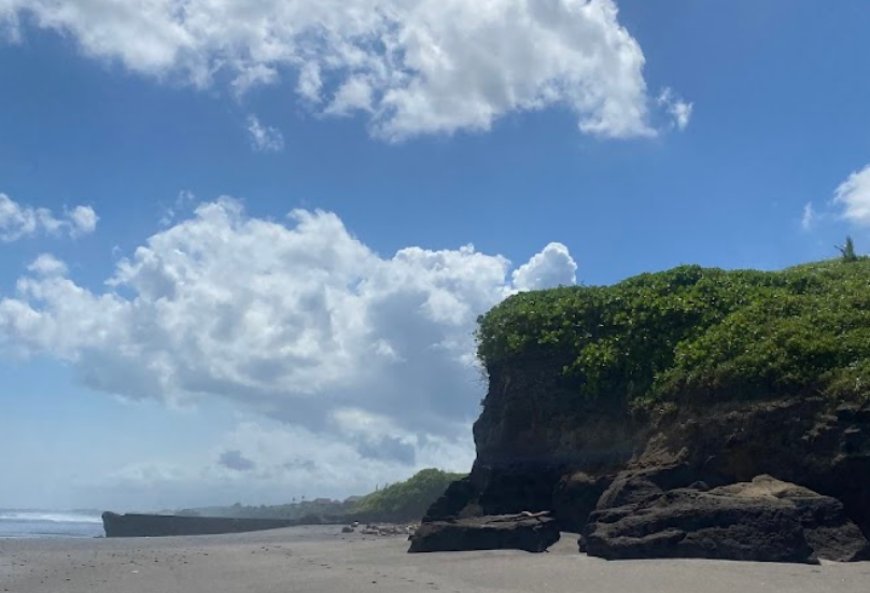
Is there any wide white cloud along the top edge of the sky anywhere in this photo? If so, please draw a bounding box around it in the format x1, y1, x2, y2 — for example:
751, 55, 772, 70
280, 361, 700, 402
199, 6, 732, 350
0, 0, 691, 140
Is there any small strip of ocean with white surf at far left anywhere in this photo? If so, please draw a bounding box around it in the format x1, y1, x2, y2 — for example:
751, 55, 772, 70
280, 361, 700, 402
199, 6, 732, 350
0, 510, 105, 538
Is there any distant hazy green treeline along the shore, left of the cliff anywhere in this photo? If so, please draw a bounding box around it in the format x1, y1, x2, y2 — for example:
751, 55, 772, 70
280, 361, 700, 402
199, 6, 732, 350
173, 469, 464, 523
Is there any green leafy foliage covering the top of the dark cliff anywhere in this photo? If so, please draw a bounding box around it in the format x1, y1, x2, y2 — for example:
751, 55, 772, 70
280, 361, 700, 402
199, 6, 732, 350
478, 258, 870, 405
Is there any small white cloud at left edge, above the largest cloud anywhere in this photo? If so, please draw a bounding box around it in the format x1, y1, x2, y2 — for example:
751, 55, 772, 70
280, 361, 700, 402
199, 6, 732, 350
0, 193, 98, 243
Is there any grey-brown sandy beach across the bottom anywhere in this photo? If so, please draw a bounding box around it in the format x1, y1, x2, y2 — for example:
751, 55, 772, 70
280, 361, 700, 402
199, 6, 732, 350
0, 527, 870, 593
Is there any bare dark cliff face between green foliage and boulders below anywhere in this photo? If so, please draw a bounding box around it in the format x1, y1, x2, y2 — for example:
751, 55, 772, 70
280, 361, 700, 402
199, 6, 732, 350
426, 359, 870, 534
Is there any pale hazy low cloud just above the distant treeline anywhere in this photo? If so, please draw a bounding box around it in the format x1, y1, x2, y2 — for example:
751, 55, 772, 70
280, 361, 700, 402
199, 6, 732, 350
99, 420, 474, 510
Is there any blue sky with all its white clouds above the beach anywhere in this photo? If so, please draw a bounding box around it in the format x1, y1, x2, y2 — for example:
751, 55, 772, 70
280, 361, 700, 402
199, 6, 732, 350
0, 0, 870, 511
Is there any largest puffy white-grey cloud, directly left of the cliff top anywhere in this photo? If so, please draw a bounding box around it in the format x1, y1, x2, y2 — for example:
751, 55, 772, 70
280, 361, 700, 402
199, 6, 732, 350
0, 198, 577, 488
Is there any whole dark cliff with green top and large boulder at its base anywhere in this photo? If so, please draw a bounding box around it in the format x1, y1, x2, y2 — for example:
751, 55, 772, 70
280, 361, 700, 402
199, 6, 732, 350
412, 260, 870, 562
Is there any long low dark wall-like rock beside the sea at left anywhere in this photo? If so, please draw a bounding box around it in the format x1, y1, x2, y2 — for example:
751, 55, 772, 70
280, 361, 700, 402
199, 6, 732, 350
103, 511, 304, 537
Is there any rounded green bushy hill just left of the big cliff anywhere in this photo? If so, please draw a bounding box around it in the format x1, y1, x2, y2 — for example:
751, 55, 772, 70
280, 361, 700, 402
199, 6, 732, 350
352, 469, 465, 521
